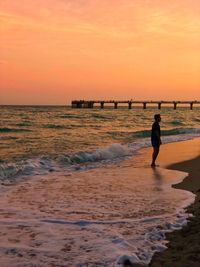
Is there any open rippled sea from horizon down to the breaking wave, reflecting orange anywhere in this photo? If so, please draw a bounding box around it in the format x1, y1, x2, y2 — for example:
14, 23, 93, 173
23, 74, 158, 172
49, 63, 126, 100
0, 106, 200, 177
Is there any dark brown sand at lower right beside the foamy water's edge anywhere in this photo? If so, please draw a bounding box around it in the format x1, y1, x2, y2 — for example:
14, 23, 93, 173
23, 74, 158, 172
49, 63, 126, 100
149, 138, 200, 267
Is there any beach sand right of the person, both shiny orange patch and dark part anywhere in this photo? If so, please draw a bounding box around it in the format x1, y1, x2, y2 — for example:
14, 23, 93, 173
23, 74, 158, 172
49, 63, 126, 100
145, 139, 200, 267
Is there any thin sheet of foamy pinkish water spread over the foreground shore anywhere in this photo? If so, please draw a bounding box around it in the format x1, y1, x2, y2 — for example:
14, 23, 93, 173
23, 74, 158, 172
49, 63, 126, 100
0, 157, 194, 267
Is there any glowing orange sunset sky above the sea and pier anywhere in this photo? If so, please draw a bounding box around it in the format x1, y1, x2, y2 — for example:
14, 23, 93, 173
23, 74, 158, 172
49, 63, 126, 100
0, 0, 200, 104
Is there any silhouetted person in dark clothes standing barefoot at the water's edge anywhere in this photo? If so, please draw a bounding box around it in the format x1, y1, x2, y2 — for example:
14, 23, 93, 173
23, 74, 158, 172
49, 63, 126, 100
151, 114, 162, 167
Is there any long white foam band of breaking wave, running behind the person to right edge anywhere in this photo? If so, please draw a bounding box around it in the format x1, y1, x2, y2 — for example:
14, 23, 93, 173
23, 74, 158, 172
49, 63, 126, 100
0, 132, 200, 180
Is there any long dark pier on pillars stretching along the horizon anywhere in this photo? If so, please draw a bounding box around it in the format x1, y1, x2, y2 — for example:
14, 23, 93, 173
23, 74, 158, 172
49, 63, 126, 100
71, 99, 200, 110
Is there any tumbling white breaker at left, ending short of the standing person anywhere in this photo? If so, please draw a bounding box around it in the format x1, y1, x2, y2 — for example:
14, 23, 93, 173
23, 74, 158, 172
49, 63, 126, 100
0, 144, 132, 180
